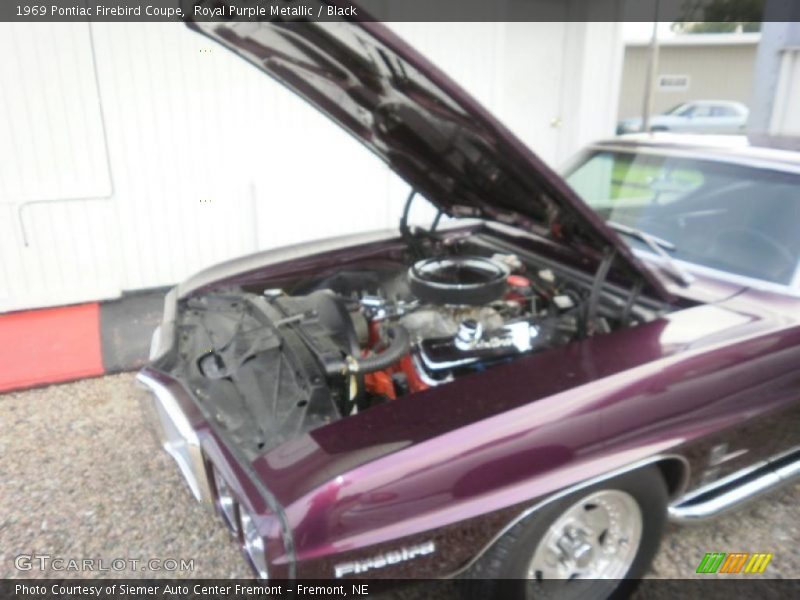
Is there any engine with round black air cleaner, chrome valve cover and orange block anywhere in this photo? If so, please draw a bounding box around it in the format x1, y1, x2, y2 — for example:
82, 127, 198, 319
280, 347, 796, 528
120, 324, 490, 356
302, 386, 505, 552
350, 255, 575, 398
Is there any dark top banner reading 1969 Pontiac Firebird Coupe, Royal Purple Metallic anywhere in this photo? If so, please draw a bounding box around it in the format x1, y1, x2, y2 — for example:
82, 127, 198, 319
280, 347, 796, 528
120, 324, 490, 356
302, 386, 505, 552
0, 0, 800, 22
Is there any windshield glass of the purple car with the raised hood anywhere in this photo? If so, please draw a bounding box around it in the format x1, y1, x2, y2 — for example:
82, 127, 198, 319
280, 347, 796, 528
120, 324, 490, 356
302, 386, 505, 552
567, 151, 800, 284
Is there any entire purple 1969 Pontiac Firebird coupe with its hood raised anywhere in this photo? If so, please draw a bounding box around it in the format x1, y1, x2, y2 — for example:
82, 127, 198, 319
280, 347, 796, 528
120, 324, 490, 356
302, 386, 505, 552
138, 7, 800, 597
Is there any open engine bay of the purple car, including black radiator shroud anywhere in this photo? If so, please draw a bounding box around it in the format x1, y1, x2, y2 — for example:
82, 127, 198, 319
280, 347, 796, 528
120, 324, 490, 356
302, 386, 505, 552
173, 237, 664, 456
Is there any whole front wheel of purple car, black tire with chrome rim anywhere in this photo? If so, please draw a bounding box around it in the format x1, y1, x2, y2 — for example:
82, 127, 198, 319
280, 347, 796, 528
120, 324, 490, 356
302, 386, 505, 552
463, 466, 668, 600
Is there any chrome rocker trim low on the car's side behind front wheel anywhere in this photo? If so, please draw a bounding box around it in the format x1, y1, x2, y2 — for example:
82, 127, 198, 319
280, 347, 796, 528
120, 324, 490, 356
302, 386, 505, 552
669, 453, 800, 523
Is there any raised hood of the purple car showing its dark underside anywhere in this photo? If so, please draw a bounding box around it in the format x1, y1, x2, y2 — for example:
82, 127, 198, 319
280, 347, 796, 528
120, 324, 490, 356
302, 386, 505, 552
190, 5, 670, 299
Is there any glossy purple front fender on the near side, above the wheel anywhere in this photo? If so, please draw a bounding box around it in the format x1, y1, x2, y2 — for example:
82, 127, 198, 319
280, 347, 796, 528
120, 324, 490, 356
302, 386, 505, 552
255, 290, 800, 576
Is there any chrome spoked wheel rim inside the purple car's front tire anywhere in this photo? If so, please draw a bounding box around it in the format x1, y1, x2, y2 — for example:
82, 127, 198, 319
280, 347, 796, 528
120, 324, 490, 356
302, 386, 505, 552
527, 490, 642, 581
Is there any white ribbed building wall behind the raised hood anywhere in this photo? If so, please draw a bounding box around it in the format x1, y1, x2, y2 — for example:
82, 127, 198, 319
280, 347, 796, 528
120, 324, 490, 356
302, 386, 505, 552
0, 23, 621, 311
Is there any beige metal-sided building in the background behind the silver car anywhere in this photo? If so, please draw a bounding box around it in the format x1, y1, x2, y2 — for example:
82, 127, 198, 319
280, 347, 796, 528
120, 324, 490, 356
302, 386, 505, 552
618, 33, 760, 119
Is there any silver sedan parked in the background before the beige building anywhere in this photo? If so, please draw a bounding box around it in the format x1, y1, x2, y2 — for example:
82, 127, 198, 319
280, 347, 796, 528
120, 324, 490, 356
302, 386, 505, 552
617, 100, 749, 134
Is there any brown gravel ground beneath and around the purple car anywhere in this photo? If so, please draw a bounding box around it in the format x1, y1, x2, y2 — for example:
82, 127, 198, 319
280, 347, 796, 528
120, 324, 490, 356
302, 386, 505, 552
0, 374, 800, 578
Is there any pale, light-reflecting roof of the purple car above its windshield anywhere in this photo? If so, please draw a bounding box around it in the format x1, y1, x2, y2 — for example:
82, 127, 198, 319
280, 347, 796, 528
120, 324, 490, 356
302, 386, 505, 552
592, 132, 800, 171
